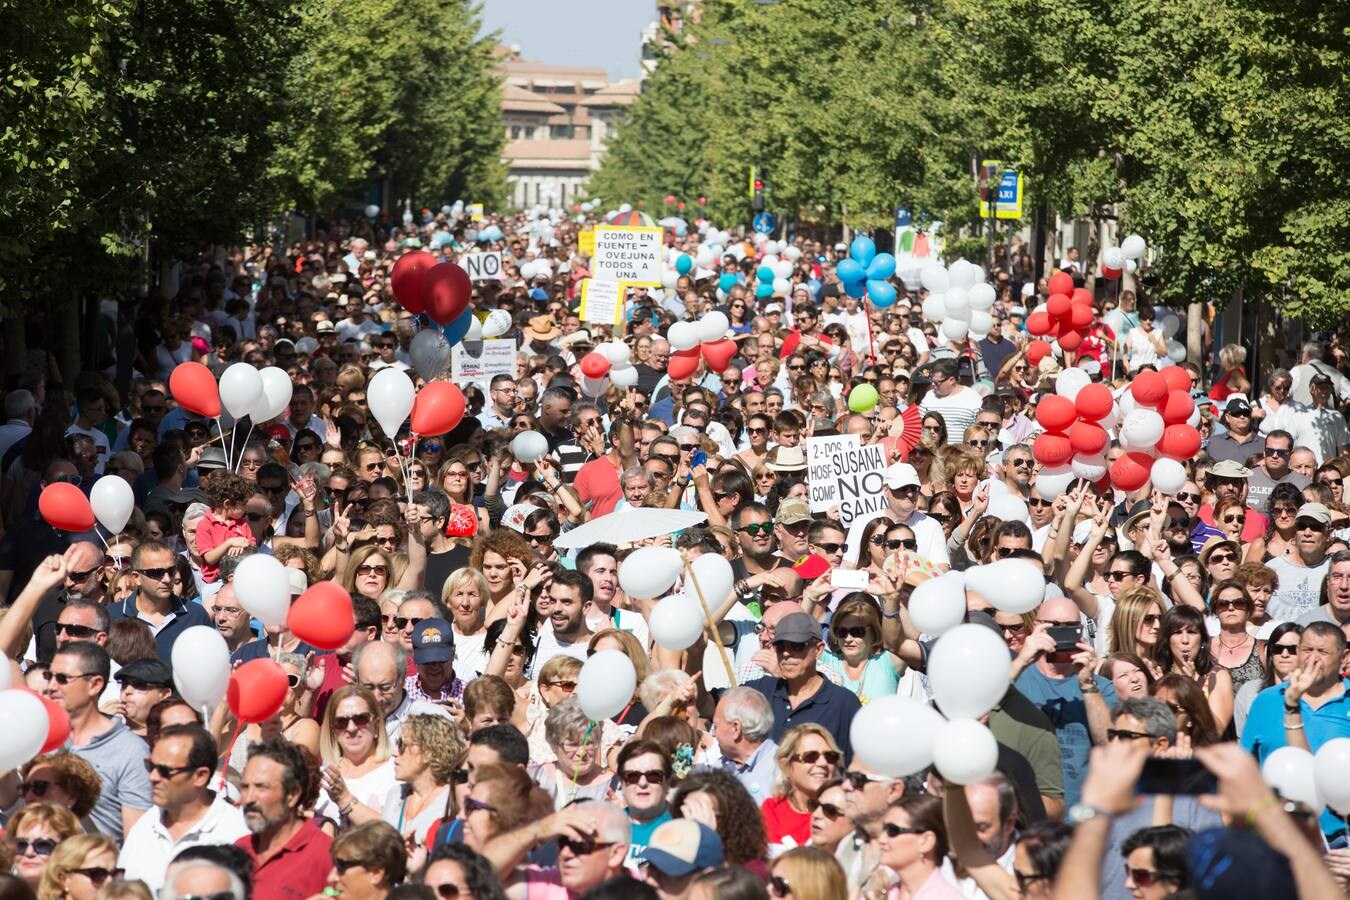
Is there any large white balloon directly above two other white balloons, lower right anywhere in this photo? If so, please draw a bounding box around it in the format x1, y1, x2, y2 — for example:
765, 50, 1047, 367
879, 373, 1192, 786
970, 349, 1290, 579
927, 623, 1011, 719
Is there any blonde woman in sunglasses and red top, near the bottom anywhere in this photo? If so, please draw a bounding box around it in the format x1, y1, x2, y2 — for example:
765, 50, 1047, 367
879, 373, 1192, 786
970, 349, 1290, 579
760, 722, 844, 846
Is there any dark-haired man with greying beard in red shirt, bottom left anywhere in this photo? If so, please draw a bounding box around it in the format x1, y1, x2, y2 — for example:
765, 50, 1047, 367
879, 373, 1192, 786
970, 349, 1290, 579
235, 737, 333, 900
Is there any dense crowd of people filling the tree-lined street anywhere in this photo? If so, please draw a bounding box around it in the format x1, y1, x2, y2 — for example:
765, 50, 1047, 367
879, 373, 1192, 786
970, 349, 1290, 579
0, 202, 1350, 900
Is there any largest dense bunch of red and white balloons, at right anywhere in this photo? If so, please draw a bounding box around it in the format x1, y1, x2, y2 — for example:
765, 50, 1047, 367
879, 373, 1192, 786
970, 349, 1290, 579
1031, 366, 1200, 499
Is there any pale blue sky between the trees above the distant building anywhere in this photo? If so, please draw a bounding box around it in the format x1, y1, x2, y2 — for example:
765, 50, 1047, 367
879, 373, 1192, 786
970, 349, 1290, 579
483, 0, 656, 81
